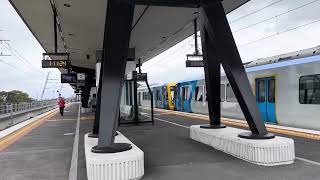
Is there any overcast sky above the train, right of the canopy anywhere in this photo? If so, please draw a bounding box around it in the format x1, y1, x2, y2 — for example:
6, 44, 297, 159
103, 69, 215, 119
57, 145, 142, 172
142, 0, 320, 84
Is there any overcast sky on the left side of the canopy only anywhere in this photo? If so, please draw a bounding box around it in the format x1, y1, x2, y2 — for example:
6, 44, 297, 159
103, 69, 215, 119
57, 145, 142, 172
0, 0, 73, 99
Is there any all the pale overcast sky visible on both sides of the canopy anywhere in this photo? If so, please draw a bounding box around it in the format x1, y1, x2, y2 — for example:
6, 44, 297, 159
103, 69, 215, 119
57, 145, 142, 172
0, 0, 320, 98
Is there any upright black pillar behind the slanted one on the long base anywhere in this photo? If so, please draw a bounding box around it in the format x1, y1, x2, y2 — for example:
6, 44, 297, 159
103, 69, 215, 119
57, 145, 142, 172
200, 26, 226, 129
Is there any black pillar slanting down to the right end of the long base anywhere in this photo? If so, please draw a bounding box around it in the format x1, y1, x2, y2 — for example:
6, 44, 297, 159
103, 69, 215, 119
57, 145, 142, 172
200, 0, 274, 139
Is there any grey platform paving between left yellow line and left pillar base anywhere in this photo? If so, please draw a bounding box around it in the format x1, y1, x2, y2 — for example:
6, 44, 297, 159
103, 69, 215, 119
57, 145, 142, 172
0, 104, 92, 180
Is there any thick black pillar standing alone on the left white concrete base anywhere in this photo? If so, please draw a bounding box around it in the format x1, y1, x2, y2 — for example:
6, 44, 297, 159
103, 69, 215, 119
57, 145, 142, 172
92, 0, 134, 153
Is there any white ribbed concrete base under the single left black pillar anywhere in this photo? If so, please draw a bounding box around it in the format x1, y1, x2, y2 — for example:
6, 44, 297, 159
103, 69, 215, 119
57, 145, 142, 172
84, 132, 144, 180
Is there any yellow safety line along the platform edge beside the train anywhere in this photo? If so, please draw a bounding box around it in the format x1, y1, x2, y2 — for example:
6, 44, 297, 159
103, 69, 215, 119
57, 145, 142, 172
150, 109, 320, 140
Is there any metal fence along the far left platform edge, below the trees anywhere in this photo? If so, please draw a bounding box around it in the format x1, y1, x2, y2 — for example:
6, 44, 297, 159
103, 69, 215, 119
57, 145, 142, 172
0, 100, 57, 119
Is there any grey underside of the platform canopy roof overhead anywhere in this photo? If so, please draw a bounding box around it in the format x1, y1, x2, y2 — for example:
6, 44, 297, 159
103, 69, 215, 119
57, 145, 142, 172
9, 0, 249, 69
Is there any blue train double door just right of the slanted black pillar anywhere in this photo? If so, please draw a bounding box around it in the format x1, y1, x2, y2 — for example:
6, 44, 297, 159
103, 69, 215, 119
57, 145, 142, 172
256, 77, 277, 123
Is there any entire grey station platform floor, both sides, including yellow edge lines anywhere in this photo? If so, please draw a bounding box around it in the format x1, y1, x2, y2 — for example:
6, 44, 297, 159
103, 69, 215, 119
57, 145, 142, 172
0, 103, 320, 180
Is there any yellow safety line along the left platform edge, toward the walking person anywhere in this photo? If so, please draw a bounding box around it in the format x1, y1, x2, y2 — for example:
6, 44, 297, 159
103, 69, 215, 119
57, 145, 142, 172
0, 109, 58, 151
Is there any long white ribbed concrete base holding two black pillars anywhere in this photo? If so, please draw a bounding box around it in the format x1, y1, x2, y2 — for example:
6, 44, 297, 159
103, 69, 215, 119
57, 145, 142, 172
190, 125, 295, 166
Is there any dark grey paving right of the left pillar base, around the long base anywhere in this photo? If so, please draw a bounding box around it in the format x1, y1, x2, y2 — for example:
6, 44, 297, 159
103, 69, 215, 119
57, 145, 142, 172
119, 110, 320, 180
